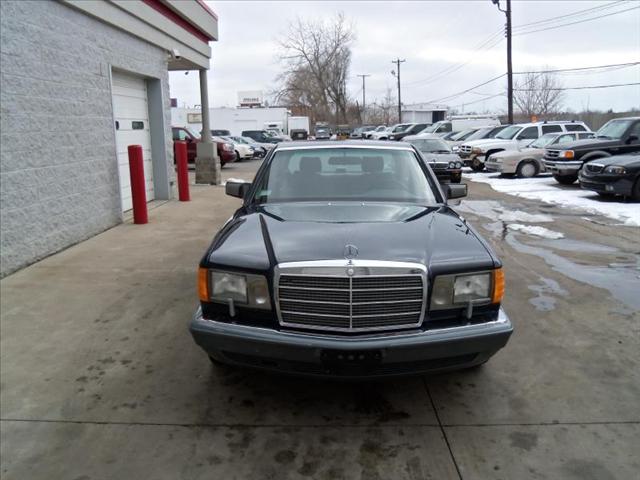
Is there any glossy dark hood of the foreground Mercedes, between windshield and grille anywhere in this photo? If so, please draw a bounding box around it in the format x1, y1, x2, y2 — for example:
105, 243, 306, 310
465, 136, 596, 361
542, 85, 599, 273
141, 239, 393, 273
203, 202, 498, 273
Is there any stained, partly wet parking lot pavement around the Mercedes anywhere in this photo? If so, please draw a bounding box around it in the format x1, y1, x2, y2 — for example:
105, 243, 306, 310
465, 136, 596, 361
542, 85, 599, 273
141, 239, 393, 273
0, 161, 640, 480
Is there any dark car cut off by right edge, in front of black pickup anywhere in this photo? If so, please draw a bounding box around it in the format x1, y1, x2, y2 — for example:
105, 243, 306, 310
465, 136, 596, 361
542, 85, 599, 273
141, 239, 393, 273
578, 152, 640, 200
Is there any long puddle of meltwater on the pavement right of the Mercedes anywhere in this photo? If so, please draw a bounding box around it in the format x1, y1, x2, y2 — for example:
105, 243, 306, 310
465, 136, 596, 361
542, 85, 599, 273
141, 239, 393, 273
505, 233, 640, 310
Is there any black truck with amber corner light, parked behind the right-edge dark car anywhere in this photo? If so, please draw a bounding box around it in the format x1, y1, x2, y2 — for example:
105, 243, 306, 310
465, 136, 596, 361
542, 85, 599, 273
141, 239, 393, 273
544, 117, 640, 185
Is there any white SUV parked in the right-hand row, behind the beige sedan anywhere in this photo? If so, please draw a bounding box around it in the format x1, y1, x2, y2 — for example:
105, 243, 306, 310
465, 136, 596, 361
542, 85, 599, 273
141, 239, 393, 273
458, 121, 591, 172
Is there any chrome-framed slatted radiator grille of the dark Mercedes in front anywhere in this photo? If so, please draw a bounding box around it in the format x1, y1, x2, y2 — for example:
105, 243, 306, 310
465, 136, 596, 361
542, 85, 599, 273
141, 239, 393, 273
276, 260, 426, 332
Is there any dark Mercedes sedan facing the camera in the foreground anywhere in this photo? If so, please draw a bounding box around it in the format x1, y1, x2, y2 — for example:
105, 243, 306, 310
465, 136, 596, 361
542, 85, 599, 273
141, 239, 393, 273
190, 141, 513, 378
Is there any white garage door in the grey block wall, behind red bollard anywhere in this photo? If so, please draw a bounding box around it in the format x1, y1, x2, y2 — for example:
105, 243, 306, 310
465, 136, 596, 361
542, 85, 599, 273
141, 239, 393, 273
112, 71, 154, 212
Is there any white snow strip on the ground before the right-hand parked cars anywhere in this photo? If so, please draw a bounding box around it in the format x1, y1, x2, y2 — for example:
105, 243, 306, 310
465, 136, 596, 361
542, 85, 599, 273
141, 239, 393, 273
464, 173, 640, 226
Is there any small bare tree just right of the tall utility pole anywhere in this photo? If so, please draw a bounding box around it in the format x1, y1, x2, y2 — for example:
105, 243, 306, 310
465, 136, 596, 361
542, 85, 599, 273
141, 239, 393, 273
513, 73, 565, 117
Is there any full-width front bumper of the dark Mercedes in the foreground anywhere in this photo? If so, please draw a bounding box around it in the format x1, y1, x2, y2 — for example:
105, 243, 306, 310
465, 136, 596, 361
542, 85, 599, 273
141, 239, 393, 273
190, 308, 513, 378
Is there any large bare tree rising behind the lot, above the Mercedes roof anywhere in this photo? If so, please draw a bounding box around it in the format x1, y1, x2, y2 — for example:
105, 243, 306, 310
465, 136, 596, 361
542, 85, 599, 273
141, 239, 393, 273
276, 13, 355, 123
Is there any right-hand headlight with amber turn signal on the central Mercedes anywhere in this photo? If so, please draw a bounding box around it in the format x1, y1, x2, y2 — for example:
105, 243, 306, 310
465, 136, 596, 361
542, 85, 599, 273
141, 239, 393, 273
431, 268, 504, 310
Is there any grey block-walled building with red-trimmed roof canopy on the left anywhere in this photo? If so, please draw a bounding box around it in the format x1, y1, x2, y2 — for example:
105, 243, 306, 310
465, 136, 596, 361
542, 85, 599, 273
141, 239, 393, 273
0, 0, 218, 276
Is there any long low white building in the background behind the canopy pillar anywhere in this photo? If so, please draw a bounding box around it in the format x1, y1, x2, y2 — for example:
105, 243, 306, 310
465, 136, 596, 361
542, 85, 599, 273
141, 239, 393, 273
171, 107, 289, 135
